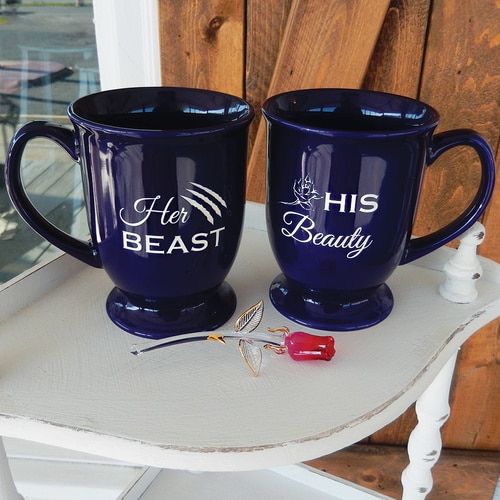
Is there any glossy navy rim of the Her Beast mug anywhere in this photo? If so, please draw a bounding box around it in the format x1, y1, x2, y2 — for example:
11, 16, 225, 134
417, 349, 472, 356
67, 85, 255, 137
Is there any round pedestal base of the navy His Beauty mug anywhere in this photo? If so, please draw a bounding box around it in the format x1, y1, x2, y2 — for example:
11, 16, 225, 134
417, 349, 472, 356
269, 274, 394, 331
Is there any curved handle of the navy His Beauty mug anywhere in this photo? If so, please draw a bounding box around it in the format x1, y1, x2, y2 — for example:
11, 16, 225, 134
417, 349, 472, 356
400, 129, 495, 264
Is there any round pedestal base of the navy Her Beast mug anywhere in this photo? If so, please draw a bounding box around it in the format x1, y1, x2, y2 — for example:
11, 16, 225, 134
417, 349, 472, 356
106, 282, 236, 339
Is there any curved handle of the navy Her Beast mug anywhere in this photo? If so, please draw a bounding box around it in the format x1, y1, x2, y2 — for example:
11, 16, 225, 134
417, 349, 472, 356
5, 121, 102, 267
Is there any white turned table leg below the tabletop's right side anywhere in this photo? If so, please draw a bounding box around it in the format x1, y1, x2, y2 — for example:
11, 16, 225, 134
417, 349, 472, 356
401, 354, 457, 500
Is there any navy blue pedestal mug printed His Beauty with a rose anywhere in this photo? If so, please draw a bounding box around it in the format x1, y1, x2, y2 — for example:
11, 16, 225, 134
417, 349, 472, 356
263, 89, 495, 331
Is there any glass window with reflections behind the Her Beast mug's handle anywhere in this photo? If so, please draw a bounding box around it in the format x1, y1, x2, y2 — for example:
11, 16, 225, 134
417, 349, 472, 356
0, 0, 100, 282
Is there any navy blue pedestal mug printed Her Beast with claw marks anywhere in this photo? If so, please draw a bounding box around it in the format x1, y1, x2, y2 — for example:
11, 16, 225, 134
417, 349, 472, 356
5, 87, 254, 338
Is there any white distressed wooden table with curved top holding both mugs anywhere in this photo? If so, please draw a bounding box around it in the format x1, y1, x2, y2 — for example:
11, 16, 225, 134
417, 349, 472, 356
0, 204, 500, 499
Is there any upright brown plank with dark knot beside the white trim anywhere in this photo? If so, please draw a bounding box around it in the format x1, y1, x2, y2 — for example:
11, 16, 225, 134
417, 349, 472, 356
159, 0, 245, 96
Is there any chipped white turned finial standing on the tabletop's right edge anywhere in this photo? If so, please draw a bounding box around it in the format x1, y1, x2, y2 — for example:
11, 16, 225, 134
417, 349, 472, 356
439, 222, 485, 304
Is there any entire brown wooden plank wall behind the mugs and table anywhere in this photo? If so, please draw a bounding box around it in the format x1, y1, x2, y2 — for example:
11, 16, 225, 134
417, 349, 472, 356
159, 0, 500, 449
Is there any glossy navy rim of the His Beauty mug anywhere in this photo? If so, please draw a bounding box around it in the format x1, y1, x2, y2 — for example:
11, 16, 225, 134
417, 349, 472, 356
262, 87, 440, 138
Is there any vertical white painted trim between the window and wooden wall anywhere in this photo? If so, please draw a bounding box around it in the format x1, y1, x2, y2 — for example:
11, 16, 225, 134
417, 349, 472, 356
93, 0, 161, 90
